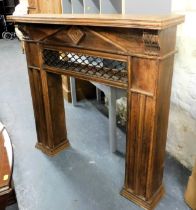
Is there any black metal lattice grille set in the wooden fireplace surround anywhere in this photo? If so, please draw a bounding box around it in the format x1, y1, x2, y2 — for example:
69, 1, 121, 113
43, 49, 128, 83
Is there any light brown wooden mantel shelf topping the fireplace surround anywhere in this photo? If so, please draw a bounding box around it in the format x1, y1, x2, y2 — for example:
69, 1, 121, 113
7, 14, 184, 30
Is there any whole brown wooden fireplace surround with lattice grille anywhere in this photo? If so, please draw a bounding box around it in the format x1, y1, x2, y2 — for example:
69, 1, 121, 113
9, 14, 184, 209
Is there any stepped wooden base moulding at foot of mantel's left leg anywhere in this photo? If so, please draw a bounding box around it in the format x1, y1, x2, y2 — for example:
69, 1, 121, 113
35, 140, 70, 156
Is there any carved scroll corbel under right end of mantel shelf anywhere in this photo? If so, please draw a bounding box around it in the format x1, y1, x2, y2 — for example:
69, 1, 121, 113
142, 31, 160, 55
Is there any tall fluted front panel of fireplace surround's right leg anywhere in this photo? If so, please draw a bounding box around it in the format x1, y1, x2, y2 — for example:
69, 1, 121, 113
125, 93, 155, 197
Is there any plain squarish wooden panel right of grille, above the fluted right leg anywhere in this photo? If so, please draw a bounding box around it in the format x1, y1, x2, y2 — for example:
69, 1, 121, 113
131, 58, 158, 95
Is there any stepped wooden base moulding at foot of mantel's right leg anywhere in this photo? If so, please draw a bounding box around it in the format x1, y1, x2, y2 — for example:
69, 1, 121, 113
120, 186, 165, 210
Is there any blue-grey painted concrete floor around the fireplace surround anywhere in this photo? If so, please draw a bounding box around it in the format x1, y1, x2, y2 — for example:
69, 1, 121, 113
0, 40, 190, 210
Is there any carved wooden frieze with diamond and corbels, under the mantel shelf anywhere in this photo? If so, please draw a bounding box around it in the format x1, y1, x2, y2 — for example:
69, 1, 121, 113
19, 24, 160, 56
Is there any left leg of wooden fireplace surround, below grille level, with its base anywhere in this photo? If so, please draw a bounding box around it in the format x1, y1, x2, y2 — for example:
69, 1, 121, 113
26, 62, 69, 155
